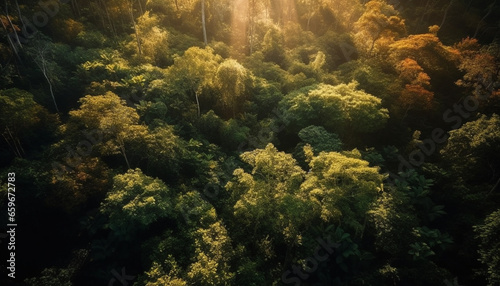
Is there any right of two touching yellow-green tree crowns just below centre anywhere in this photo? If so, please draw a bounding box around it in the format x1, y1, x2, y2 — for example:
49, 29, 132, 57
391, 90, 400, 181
301, 147, 384, 236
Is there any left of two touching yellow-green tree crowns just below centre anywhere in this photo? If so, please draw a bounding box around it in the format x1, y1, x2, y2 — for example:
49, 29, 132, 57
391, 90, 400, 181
226, 144, 311, 249
